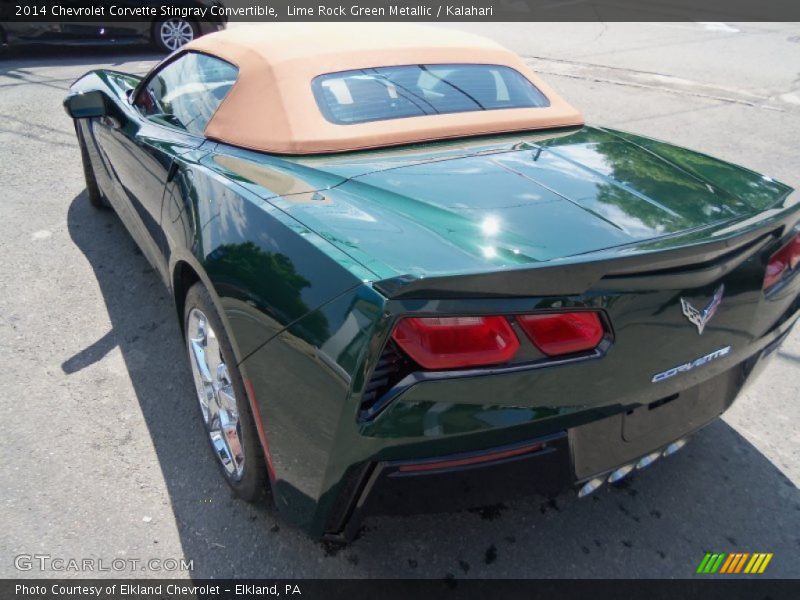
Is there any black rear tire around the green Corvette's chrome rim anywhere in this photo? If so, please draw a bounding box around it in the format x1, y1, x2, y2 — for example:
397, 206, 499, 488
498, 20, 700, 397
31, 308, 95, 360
183, 282, 269, 502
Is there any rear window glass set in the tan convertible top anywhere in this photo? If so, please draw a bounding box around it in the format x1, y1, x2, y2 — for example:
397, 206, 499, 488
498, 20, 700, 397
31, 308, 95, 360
311, 64, 550, 125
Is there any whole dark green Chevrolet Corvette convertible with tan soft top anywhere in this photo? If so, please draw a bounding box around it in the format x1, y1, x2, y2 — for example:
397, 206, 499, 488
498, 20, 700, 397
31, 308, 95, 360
65, 24, 800, 540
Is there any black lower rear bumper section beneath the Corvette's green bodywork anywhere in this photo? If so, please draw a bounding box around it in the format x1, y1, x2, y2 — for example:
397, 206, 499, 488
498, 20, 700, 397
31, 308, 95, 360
326, 315, 797, 541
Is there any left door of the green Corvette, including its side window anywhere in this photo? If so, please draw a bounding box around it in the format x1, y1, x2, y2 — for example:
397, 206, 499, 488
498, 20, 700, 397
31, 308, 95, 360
96, 52, 238, 282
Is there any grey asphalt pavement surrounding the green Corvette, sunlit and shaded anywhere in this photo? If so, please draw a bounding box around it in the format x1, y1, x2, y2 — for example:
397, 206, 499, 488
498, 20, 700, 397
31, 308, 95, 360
0, 23, 800, 578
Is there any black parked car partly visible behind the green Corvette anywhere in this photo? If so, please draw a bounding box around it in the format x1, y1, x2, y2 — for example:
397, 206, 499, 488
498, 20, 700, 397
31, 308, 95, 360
0, 0, 226, 52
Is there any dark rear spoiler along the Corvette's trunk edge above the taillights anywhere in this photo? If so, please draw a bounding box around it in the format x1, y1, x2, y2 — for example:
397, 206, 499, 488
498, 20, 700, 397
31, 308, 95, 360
373, 205, 800, 299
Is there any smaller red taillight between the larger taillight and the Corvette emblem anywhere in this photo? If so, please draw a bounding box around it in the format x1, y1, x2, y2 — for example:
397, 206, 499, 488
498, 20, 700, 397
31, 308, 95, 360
517, 312, 603, 356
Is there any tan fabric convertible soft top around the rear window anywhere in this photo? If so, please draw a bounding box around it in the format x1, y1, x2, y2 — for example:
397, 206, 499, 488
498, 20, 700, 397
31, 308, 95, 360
185, 23, 583, 154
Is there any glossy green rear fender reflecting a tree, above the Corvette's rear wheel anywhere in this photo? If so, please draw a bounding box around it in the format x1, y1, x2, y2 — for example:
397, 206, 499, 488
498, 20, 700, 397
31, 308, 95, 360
161, 152, 374, 362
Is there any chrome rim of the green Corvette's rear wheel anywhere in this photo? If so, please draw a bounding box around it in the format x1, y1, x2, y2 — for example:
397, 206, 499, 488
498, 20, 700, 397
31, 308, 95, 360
186, 308, 244, 479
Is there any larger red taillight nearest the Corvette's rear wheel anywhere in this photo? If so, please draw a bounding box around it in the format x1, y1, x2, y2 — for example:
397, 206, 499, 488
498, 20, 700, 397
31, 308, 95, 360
392, 317, 519, 369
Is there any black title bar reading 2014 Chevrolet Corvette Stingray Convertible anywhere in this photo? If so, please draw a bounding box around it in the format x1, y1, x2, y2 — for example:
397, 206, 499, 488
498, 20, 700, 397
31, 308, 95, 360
0, 0, 800, 24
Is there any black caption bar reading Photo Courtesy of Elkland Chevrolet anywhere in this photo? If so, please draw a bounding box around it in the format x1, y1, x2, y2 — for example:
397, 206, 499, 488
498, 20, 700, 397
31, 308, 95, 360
0, 575, 800, 600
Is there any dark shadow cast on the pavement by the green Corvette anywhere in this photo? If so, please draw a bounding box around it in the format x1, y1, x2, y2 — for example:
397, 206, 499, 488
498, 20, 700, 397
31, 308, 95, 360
62, 192, 800, 578
